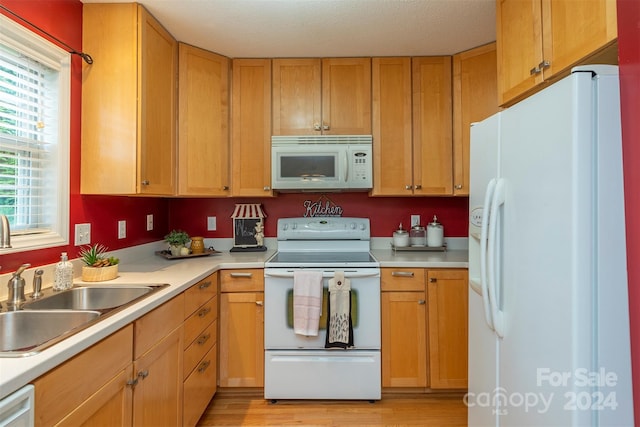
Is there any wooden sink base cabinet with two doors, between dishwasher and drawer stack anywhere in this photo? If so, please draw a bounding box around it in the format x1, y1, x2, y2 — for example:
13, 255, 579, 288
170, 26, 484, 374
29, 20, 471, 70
34, 295, 184, 426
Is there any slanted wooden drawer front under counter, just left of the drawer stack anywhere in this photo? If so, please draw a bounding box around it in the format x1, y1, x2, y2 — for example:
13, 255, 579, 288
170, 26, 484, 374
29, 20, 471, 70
133, 294, 184, 359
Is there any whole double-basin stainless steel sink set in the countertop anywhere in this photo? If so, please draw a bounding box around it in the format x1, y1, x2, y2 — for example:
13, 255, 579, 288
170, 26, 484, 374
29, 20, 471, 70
0, 284, 167, 357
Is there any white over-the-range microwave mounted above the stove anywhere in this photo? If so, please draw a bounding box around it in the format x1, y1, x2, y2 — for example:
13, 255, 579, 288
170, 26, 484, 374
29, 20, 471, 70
271, 135, 373, 192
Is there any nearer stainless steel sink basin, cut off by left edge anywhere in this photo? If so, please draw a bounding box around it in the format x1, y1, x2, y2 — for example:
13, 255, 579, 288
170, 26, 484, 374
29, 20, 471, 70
0, 310, 100, 356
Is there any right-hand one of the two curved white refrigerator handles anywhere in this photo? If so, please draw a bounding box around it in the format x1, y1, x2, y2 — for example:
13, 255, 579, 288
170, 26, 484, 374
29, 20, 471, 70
487, 178, 504, 338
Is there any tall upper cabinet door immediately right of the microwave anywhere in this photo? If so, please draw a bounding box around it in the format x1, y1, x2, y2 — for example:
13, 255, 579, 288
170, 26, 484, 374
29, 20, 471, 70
371, 58, 413, 196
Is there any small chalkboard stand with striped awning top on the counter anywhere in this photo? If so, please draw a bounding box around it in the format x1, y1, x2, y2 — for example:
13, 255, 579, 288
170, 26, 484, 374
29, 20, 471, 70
231, 203, 267, 252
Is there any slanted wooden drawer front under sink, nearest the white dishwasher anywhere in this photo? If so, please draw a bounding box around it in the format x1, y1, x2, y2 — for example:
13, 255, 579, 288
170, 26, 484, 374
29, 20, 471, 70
34, 325, 133, 426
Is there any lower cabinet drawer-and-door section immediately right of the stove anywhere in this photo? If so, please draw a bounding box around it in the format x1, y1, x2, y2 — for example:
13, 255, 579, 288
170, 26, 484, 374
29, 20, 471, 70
380, 268, 428, 387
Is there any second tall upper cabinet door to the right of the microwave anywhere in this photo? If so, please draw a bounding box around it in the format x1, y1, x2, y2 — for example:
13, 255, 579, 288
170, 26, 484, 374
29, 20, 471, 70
413, 56, 453, 195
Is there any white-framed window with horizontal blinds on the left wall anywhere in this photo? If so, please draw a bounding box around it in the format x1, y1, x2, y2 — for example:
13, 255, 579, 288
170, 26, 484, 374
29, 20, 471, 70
0, 15, 71, 253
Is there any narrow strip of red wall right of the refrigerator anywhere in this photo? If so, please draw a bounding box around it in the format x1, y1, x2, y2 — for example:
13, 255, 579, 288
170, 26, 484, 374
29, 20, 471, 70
617, 0, 640, 425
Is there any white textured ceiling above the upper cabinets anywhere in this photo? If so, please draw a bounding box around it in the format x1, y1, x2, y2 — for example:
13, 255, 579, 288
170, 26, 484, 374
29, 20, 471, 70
82, 0, 495, 58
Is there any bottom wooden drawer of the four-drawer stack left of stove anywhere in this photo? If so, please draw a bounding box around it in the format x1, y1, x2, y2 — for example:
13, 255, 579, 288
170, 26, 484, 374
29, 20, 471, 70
183, 345, 218, 426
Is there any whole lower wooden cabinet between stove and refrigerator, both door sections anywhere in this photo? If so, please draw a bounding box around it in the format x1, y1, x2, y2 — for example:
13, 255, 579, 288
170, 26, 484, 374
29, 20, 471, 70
381, 268, 468, 389
